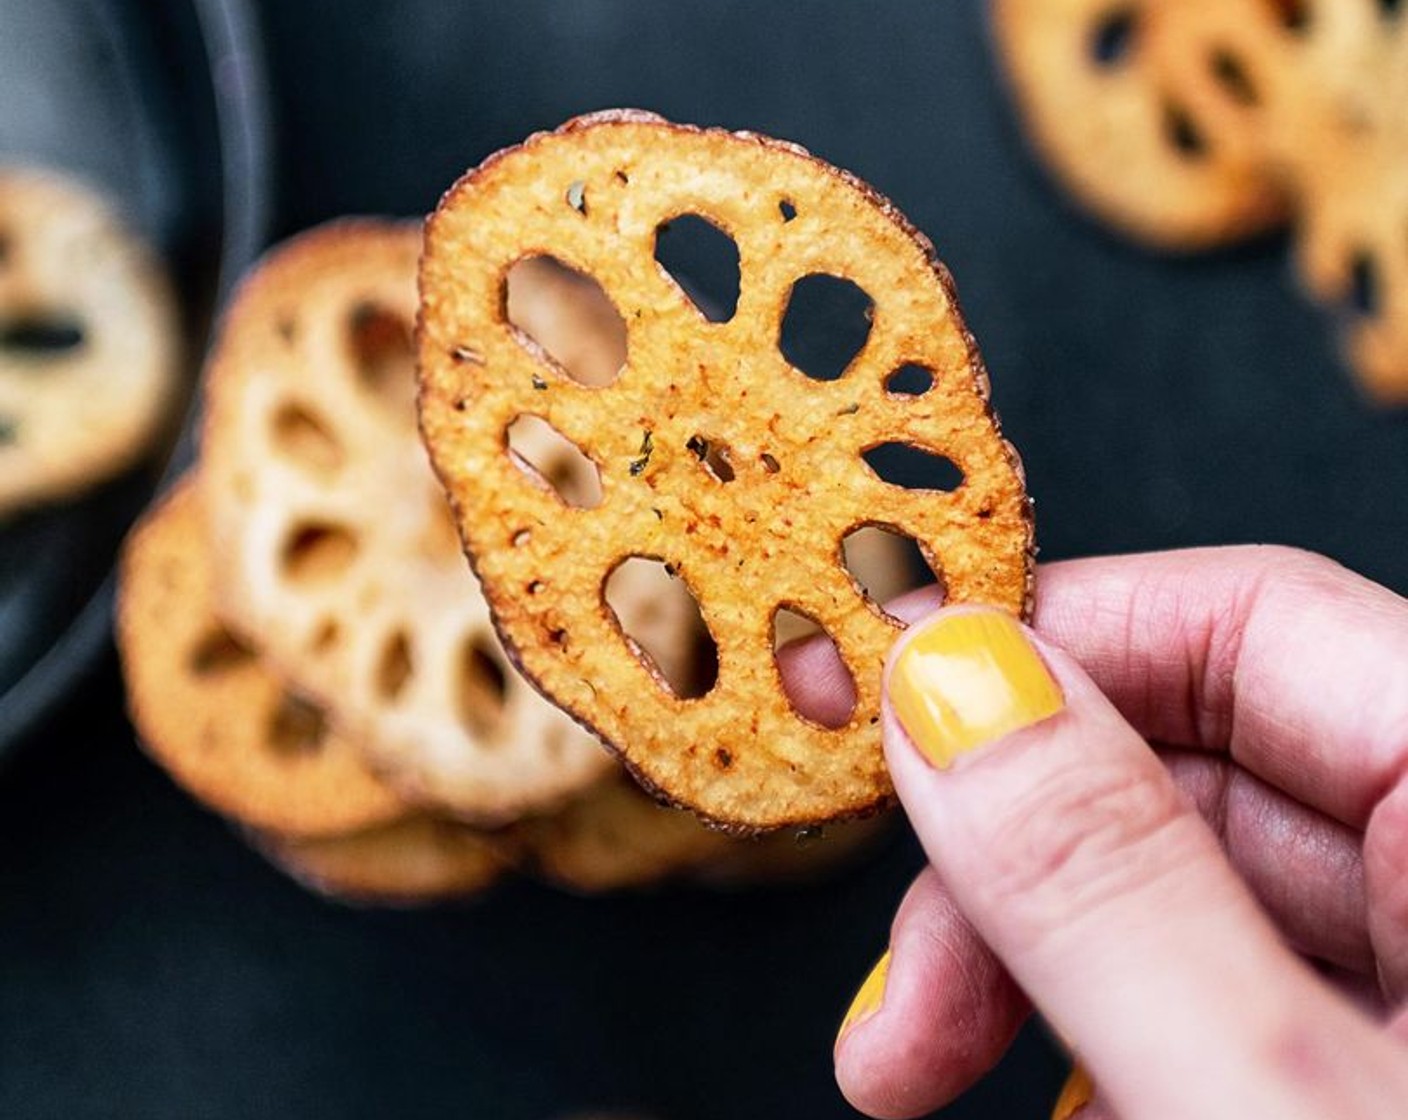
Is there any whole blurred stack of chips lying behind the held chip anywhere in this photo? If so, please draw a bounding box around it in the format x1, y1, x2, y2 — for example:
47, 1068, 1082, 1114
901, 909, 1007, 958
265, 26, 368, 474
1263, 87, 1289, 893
118, 194, 934, 904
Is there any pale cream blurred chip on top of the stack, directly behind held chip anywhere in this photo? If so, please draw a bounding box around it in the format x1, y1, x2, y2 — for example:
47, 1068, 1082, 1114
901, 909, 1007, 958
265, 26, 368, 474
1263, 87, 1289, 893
203, 220, 621, 826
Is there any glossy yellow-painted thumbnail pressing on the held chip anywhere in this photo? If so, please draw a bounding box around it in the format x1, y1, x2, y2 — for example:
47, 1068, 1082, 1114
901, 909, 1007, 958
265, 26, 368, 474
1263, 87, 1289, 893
890, 610, 1066, 769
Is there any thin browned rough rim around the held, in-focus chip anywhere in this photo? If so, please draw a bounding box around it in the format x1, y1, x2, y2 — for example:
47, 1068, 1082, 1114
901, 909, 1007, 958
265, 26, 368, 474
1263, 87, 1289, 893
414, 108, 1036, 837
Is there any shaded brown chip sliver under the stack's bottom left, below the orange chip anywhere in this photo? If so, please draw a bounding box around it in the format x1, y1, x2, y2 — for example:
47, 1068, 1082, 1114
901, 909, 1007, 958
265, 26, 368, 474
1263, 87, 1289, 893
252, 816, 508, 906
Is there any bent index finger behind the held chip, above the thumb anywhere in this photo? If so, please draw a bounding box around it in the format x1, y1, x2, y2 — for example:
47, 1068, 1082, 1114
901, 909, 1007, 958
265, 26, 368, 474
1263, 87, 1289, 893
1033, 547, 1408, 828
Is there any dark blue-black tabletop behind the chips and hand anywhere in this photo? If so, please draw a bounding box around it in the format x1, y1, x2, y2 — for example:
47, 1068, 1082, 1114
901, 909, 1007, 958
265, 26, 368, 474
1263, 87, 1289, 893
0, 0, 1408, 1120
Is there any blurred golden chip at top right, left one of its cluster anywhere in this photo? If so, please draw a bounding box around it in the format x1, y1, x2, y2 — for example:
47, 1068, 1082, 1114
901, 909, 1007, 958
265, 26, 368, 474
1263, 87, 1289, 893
993, 0, 1287, 249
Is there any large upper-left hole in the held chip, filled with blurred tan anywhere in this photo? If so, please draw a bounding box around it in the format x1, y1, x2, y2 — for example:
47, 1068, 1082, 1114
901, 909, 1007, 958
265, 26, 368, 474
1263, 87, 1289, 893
503, 254, 627, 392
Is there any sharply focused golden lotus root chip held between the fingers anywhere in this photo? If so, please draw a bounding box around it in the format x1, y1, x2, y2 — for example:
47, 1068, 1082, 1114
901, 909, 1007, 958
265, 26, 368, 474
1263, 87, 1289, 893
420, 111, 1032, 831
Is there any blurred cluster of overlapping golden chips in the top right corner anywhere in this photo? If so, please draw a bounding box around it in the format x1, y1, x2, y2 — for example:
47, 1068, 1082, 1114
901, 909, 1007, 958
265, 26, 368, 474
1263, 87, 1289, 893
991, 0, 1408, 406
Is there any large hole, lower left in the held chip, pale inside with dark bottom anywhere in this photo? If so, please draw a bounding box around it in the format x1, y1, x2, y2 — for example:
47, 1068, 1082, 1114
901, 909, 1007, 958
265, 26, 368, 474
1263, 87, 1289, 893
603, 556, 718, 700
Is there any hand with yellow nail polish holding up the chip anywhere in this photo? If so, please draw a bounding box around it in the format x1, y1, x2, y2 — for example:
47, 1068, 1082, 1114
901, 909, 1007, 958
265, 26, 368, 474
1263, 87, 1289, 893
827, 548, 1408, 1120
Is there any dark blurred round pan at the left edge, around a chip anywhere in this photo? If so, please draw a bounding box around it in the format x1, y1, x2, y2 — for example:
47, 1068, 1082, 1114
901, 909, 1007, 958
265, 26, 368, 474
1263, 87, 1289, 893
0, 0, 270, 759
